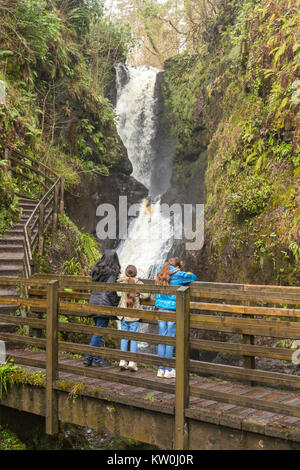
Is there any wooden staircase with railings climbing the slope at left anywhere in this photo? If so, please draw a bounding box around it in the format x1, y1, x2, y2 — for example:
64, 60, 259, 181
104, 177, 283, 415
0, 145, 64, 347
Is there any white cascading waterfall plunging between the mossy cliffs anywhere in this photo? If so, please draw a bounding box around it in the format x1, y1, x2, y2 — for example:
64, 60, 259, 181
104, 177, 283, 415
116, 64, 173, 278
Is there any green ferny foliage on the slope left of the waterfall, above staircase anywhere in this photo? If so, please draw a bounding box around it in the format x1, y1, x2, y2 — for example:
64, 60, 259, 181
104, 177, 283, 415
0, 0, 133, 191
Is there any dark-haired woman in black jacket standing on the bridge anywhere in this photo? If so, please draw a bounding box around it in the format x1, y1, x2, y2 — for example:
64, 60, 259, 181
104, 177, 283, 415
83, 250, 121, 366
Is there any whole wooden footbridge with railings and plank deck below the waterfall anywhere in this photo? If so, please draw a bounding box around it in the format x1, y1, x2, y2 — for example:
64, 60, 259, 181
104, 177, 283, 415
0, 275, 300, 449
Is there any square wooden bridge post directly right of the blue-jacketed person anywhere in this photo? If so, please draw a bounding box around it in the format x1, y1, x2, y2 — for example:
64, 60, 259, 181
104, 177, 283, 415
174, 287, 190, 450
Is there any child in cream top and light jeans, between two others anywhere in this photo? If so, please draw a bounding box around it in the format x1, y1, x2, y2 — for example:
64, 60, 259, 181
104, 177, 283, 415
118, 265, 150, 371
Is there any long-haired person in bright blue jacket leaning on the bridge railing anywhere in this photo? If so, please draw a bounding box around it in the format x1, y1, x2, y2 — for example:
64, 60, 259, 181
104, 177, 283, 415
155, 258, 197, 378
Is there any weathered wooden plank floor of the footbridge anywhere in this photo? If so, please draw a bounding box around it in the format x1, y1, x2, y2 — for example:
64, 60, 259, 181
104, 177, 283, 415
7, 349, 300, 442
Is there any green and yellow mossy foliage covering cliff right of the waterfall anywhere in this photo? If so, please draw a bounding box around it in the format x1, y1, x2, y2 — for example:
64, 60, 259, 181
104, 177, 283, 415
164, 0, 300, 285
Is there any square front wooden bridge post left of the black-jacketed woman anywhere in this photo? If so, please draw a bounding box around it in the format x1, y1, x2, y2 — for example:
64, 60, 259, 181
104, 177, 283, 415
46, 280, 59, 435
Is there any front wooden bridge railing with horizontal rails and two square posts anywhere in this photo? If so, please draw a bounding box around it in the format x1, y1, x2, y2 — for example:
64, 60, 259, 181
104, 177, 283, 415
0, 275, 300, 449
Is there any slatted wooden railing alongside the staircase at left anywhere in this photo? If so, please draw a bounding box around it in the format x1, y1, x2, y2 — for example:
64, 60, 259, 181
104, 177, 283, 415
4, 145, 64, 278
